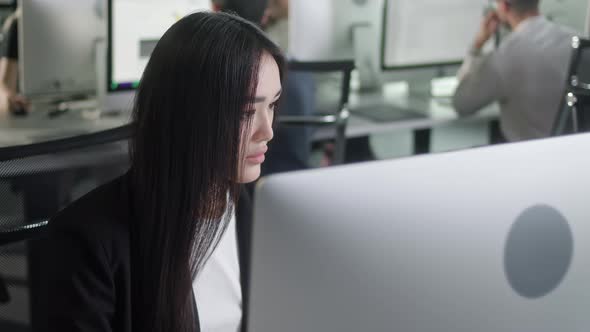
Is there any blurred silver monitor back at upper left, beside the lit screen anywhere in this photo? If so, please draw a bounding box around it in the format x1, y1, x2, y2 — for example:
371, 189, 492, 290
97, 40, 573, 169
18, 0, 104, 99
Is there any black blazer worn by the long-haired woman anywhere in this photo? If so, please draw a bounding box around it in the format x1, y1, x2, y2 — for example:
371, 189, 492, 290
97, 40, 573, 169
46, 175, 252, 332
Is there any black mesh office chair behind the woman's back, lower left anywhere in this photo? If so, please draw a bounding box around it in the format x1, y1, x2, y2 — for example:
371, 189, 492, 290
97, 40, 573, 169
0, 125, 132, 332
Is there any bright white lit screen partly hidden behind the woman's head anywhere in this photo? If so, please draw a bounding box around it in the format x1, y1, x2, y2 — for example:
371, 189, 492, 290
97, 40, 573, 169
107, 0, 211, 91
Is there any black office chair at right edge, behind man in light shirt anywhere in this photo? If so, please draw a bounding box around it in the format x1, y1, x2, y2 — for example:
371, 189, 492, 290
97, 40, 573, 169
551, 37, 590, 136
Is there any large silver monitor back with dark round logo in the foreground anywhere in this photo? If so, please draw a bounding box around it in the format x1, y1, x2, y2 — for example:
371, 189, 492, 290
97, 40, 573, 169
247, 135, 590, 332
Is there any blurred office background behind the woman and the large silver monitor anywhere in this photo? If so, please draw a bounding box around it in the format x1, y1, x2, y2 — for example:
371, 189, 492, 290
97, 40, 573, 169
0, 0, 590, 332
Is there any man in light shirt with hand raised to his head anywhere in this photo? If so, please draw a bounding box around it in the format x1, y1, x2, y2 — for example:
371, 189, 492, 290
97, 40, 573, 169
453, 0, 575, 143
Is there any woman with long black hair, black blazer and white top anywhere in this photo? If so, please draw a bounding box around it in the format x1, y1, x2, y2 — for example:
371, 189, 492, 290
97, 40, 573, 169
48, 13, 284, 332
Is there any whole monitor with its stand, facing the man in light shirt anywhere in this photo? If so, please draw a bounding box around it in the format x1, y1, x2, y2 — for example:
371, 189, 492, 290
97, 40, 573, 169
375, 0, 493, 98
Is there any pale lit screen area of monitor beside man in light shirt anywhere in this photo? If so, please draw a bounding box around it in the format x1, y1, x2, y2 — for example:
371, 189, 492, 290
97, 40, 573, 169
381, 0, 489, 70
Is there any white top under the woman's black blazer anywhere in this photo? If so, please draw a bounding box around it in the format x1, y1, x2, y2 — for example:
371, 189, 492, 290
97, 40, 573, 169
193, 214, 242, 332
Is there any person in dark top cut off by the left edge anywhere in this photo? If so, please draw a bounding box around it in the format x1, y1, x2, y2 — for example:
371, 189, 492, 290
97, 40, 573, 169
0, 9, 30, 115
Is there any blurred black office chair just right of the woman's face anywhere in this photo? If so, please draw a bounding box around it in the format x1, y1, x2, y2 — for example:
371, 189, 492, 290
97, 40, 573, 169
278, 61, 354, 164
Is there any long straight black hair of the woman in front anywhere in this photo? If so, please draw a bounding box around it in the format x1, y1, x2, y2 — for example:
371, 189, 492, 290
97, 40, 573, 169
130, 12, 284, 332
